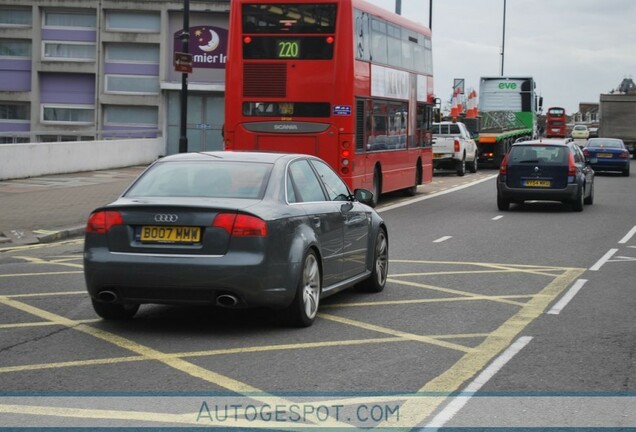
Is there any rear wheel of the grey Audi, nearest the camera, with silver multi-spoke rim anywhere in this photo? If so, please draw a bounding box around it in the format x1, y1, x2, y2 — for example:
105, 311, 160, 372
287, 250, 321, 327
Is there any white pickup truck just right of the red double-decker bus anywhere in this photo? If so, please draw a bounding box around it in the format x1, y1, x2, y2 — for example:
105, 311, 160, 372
432, 121, 478, 176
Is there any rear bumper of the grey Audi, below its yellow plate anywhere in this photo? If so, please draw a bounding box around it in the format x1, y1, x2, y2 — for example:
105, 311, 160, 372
84, 248, 300, 308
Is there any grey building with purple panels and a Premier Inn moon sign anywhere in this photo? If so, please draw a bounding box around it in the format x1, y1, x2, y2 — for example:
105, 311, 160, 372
0, 0, 230, 154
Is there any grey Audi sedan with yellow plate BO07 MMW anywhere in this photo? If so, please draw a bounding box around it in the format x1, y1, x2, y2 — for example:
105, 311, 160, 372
84, 152, 389, 327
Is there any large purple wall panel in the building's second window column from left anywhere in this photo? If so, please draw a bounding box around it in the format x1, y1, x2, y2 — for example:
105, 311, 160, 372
40, 73, 95, 105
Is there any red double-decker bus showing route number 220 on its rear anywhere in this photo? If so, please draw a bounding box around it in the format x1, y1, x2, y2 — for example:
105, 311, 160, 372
224, 0, 434, 206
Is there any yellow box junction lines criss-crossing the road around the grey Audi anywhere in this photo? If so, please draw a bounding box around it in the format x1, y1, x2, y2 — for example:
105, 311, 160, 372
0, 256, 585, 428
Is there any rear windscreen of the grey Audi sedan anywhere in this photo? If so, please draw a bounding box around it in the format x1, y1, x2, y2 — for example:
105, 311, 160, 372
124, 161, 271, 199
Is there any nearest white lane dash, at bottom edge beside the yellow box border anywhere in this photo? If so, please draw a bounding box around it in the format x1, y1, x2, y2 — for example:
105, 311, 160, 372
423, 336, 532, 430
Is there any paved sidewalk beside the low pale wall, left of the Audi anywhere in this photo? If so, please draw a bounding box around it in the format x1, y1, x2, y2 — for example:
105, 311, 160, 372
0, 166, 146, 246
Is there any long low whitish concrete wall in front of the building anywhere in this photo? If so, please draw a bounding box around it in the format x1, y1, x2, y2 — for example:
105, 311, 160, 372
0, 138, 166, 180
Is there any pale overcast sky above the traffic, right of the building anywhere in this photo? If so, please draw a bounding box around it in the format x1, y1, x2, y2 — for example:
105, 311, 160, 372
368, 0, 636, 114
